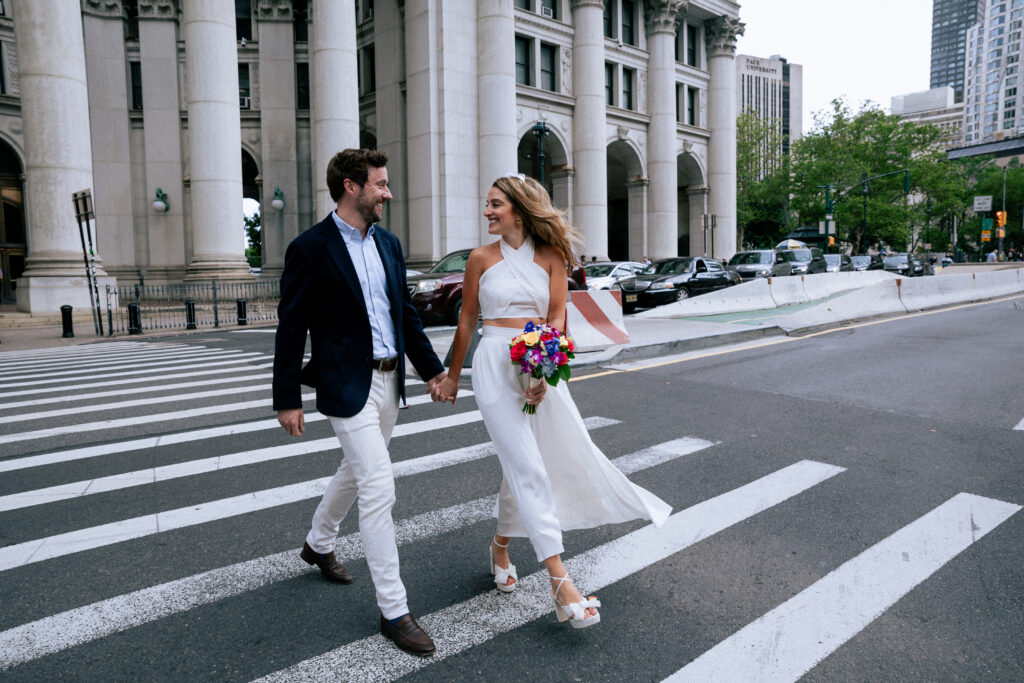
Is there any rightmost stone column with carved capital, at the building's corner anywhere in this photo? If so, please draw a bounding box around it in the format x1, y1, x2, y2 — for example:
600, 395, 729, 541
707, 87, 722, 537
705, 16, 743, 258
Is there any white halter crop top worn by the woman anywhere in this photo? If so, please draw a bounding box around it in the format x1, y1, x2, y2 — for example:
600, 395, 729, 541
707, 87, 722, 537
478, 236, 551, 321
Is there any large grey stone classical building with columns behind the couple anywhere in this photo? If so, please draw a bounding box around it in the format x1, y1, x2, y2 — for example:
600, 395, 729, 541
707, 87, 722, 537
0, 0, 742, 312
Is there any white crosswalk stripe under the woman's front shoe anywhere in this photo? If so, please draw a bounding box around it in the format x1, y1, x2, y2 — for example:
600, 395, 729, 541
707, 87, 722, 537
251, 460, 844, 682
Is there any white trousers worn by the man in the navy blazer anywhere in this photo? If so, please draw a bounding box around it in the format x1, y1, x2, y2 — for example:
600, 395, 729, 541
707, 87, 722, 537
306, 370, 409, 618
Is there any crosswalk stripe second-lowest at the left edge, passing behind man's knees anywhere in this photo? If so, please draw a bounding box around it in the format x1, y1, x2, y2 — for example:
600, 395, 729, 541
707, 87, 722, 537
0, 413, 614, 571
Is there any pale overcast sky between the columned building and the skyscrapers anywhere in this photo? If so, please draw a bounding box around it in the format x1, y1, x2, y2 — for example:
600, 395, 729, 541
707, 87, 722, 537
736, 0, 932, 131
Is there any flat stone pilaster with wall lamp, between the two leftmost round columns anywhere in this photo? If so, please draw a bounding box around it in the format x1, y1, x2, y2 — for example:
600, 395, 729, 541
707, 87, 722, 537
138, 0, 187, 285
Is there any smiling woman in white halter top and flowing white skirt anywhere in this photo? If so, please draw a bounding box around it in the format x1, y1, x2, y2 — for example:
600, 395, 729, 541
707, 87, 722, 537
436, 175, 671, 628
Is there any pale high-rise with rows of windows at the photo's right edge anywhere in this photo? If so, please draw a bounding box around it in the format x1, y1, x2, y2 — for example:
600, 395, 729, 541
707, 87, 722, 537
964, 0, 1024, 144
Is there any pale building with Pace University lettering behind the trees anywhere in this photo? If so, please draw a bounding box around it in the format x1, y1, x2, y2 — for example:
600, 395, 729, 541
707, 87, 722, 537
736, 54, 804, 173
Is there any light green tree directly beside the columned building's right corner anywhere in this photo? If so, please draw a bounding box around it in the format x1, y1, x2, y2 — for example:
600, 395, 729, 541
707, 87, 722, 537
736, 111, 791, 249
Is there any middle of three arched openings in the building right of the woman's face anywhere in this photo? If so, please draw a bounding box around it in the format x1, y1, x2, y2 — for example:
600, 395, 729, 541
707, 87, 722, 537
607, 139, 646, 261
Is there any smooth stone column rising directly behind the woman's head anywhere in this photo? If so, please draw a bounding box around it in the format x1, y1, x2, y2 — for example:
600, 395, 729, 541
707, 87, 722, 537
476, 0, 519, 244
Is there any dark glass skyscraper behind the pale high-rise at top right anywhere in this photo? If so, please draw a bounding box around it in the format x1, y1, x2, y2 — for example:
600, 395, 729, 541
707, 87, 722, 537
930, 0, 985, 103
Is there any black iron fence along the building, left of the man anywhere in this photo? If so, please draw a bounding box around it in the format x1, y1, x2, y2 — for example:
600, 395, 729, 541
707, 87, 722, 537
104, 282, 281, 337
